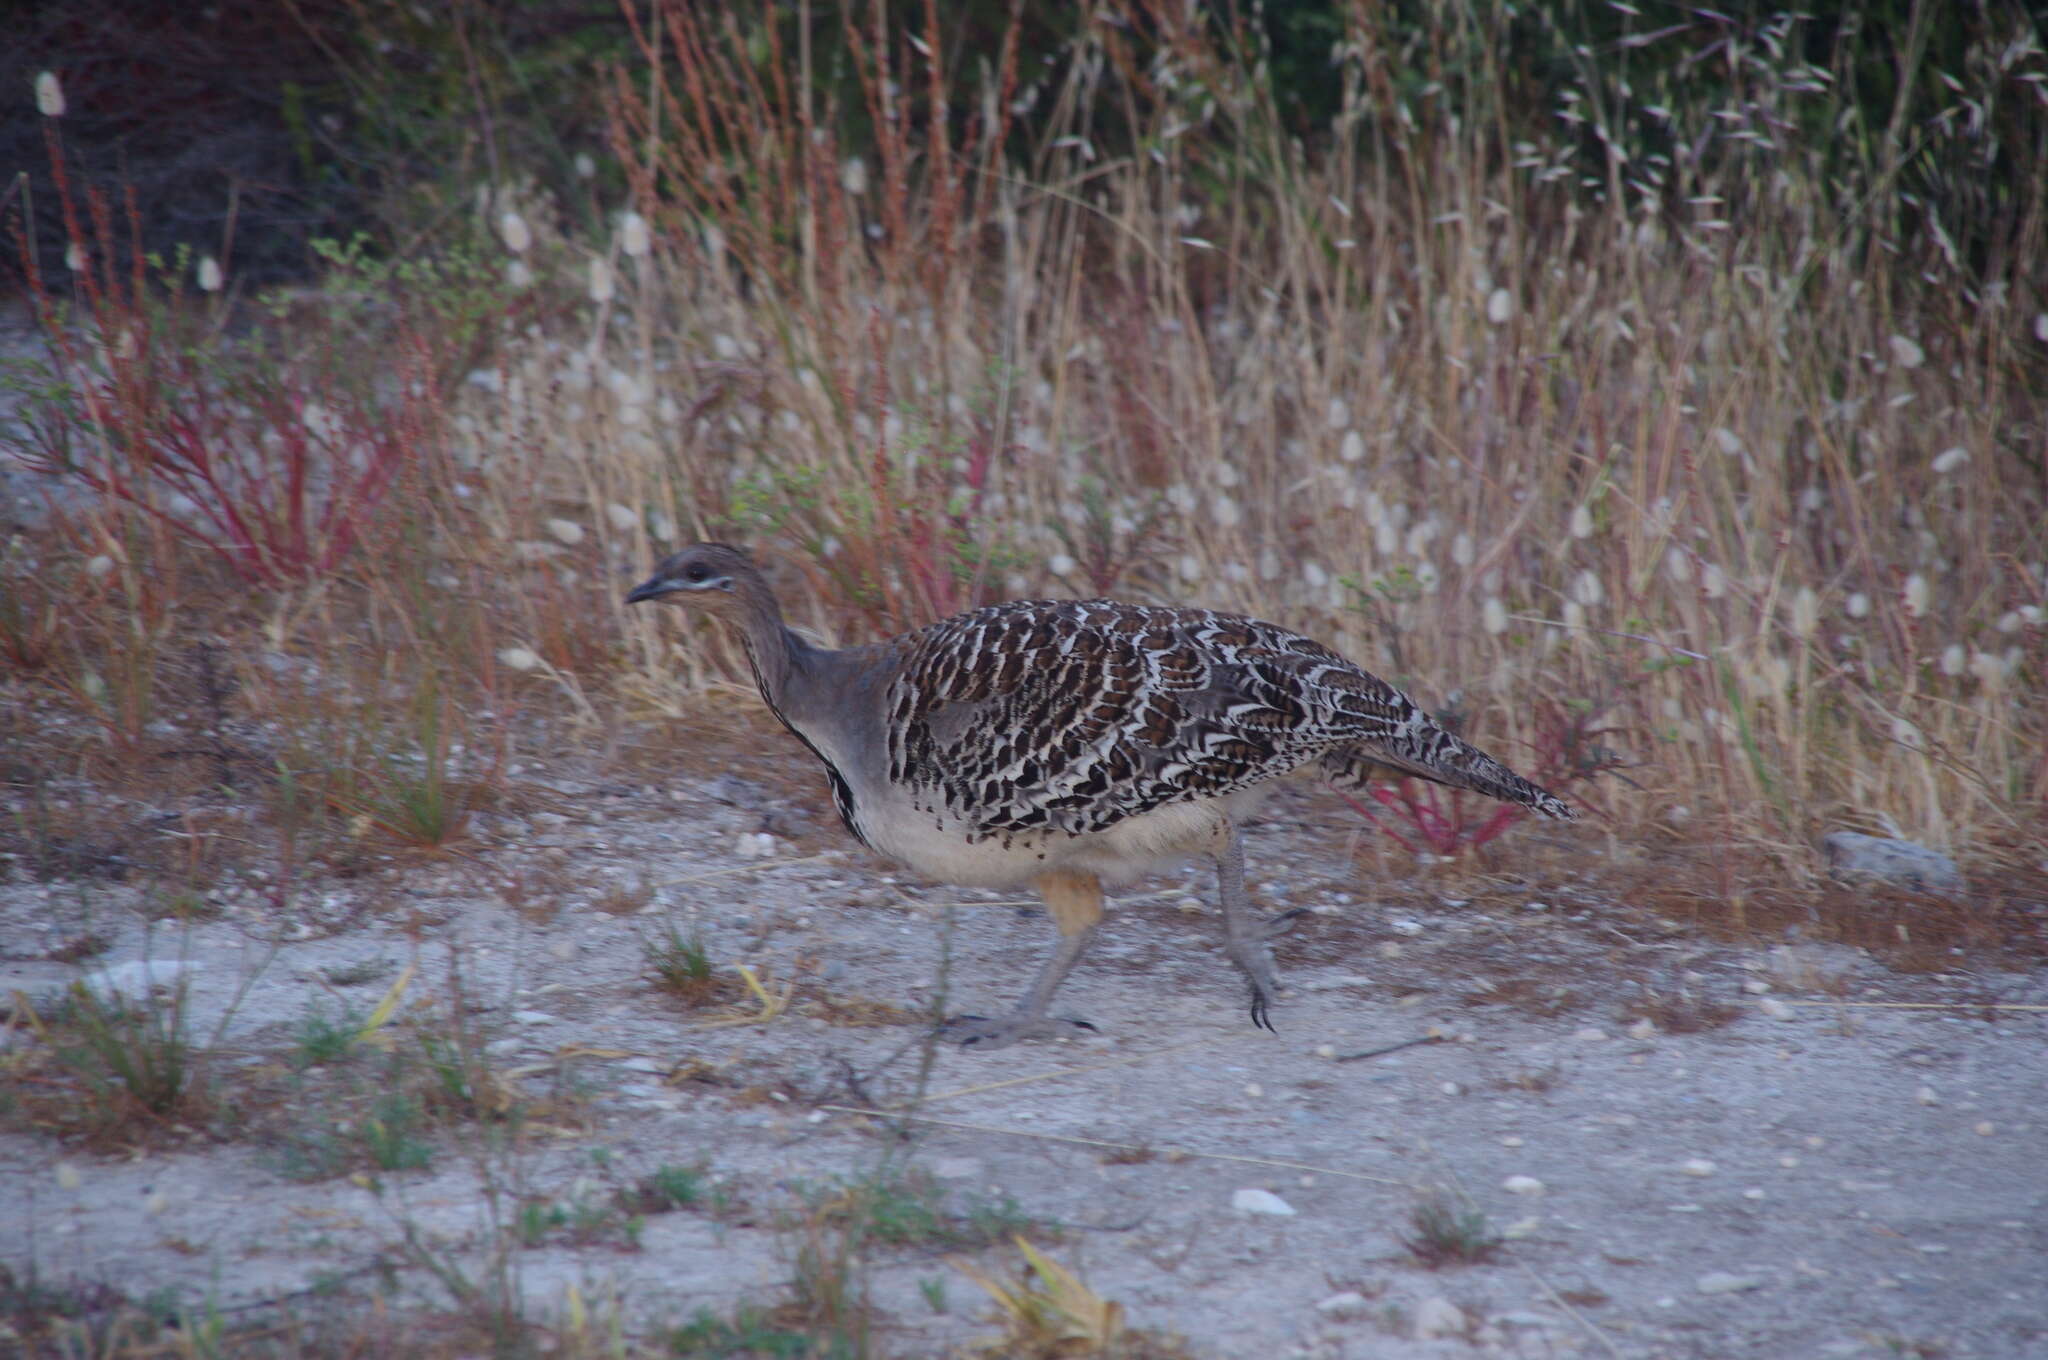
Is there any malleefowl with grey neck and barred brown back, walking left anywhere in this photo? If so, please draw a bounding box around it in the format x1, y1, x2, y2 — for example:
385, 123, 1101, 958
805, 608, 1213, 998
627, 543, 1575, 1049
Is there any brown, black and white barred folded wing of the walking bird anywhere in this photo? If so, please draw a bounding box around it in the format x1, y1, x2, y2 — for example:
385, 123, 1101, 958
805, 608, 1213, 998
889, 600, 1468, 838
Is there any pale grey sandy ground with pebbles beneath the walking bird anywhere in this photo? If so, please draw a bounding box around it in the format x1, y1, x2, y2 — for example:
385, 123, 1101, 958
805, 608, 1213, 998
0, 735, 2048, 1360
